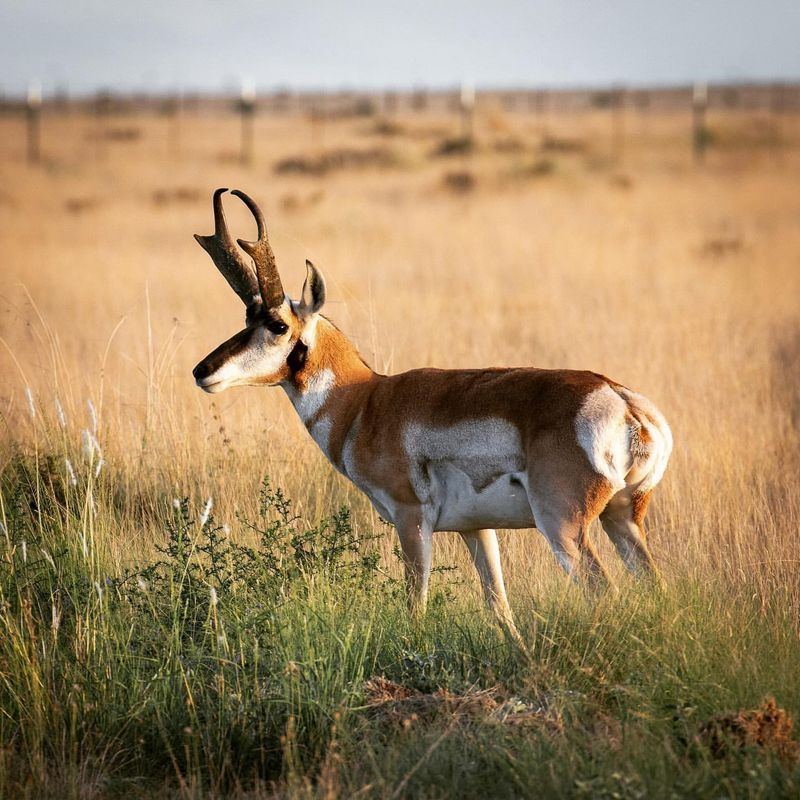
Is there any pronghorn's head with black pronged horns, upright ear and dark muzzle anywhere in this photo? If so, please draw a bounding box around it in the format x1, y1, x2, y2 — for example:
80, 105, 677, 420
192, 189, 325, 392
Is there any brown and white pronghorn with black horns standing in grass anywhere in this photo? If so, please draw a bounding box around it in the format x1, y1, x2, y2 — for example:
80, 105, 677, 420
193, 189, 672, 638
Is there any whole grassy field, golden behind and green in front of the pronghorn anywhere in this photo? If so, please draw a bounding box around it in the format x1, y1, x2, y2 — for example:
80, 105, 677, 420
0, 103, 800, 797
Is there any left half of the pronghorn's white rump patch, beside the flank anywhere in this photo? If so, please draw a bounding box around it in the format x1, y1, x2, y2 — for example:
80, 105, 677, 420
575, 386, 631, 491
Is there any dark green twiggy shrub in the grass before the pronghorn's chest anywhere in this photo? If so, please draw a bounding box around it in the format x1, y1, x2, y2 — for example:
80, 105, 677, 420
119, 478, 396, 637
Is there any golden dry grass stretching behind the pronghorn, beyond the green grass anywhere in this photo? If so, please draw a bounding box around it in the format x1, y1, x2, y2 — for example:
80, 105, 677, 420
0, 104, 800, 600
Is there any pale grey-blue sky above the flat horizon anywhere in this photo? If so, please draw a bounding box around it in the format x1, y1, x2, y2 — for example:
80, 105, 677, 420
0, 0, 800, 94
